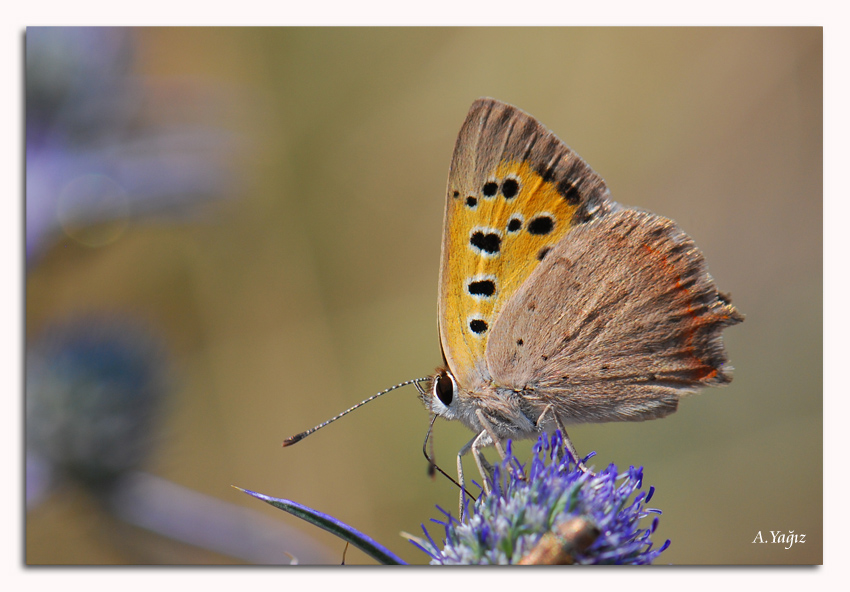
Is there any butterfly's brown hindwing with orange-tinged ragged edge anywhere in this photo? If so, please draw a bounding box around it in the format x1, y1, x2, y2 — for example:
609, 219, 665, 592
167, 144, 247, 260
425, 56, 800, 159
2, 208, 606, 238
487, 210, 743, 422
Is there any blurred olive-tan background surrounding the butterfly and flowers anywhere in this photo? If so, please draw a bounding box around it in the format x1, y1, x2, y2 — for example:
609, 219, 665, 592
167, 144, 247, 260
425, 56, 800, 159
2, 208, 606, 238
26, 28, 823, 564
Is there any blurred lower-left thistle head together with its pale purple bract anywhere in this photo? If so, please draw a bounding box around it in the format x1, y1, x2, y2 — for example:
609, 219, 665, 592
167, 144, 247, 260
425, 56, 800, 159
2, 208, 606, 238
26, 315, 334, 564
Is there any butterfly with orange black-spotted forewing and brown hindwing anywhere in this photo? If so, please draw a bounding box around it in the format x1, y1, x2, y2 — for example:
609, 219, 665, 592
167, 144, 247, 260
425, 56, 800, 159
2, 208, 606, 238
420, 98, 743, 508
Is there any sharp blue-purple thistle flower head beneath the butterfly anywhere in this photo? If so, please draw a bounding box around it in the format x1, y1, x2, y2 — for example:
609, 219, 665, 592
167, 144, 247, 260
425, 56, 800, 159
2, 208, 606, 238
413, 431, 670, 565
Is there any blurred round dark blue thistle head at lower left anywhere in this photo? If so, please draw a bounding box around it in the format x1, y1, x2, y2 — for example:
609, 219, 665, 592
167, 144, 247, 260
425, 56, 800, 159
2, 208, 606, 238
26, 315, 171, 505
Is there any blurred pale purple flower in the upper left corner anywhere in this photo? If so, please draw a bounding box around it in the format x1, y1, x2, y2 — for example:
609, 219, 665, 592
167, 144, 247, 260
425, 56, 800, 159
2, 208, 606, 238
26, 27, 235, 266
